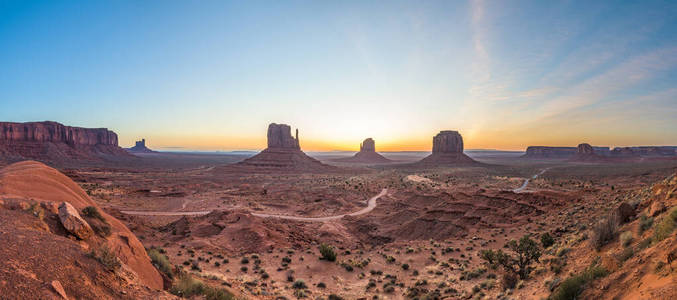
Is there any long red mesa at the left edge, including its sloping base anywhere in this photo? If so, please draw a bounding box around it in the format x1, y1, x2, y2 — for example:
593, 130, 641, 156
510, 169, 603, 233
0, 121, 129, 161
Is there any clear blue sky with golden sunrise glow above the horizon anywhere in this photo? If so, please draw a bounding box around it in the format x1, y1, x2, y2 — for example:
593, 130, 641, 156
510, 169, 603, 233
0, 0, 677, 151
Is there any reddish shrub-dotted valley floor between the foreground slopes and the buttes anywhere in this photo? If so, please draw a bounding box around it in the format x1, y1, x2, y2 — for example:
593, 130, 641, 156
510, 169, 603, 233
65, 155, 677, 299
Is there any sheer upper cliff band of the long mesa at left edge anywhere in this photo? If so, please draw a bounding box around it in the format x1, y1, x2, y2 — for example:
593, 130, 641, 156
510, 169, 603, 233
0, 121, 118, 146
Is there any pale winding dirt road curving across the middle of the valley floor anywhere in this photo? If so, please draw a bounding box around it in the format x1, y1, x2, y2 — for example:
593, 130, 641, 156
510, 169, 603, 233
120, 189, 388, 222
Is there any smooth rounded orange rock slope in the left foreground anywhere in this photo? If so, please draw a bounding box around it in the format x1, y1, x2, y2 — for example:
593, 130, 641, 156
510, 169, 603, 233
0, 161, 163, 292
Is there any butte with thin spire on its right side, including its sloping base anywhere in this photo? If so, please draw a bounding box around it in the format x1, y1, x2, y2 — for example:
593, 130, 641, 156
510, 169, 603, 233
238, 123, 336, 172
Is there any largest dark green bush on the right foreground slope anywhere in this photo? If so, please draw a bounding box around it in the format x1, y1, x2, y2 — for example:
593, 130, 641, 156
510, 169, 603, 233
480, 235, 541, 279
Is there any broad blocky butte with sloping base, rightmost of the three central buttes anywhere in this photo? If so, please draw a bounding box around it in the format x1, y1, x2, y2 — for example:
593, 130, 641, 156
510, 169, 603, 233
417, 130, 477, 166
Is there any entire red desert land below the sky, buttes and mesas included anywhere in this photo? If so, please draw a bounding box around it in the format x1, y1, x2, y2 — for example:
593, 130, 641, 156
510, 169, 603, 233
0, 122, 677, 299
